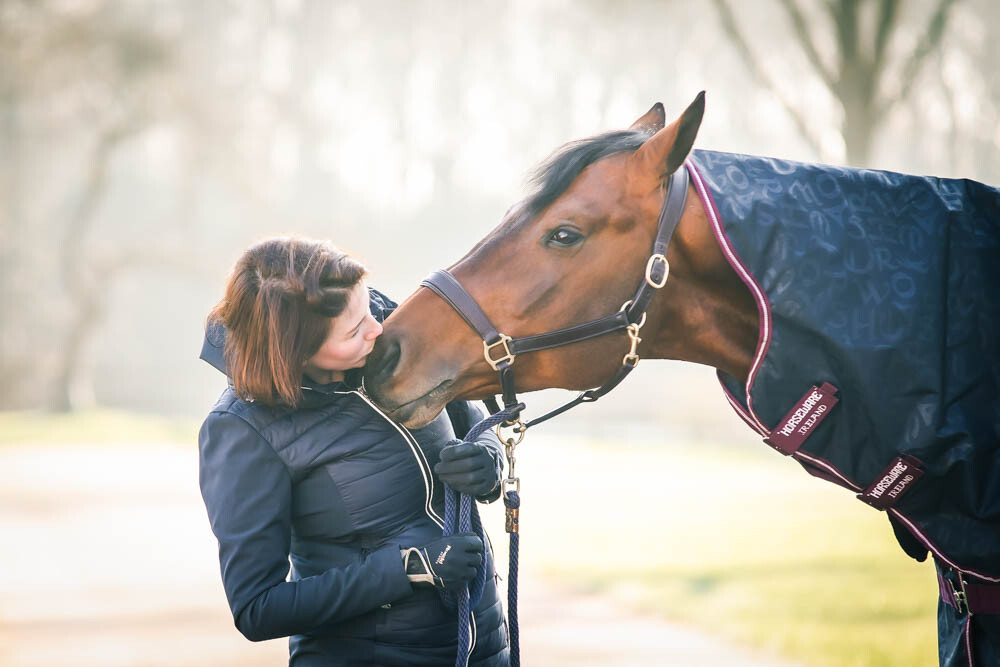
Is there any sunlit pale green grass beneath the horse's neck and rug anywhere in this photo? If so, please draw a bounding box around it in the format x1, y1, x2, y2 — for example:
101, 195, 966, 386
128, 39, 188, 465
480, 439, 937, 667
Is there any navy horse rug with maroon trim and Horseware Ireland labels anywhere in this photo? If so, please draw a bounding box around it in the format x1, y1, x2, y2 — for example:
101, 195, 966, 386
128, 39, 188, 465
688, 151, 1000, 588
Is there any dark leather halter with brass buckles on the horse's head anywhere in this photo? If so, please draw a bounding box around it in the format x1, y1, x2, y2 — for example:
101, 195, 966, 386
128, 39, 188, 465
420, 166, 688, 436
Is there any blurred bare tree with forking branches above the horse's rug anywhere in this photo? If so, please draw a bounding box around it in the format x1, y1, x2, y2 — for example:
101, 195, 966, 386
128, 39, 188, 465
714, 0, 956, 166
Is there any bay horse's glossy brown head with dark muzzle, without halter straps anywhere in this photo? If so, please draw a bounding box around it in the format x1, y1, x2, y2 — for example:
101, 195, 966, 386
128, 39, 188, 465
365, 93, 756, 426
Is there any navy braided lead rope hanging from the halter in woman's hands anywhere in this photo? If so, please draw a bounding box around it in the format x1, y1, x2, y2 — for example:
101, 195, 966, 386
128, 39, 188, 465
440, 407, 523, 667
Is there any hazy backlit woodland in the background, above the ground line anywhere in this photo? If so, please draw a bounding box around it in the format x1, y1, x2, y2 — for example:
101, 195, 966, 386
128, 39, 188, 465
0, 0, 1000, 412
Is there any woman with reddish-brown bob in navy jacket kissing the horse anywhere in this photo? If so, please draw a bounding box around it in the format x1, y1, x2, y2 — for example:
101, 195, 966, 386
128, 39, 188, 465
199, 238, 508, 667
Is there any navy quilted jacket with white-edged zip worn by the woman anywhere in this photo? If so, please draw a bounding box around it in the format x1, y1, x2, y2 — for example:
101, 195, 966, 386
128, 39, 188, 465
199, 290, 508, 666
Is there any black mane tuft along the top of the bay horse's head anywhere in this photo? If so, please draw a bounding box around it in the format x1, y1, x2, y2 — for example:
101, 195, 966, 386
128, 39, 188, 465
523, 130, 651, 217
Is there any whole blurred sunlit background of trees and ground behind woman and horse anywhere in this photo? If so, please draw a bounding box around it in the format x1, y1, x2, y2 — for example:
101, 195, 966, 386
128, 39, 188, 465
0, 0, 1000, 665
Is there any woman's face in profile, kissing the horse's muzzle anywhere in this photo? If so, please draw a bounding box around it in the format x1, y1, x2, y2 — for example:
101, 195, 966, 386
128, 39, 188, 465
305, 281, 382, 382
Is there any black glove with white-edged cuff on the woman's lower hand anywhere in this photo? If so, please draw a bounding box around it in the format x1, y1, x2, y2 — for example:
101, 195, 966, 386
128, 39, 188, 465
400, 533, 483, 588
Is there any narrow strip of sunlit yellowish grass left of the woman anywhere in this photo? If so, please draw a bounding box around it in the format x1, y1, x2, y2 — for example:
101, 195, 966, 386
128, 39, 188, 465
0, 408, 199, 445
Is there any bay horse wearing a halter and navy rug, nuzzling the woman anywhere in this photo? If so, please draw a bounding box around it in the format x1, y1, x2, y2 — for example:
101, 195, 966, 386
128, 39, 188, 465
364, 93, 1000, 664
